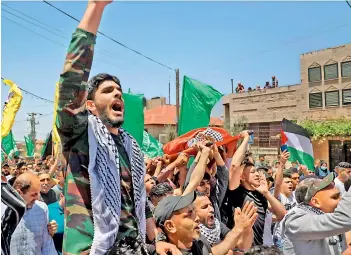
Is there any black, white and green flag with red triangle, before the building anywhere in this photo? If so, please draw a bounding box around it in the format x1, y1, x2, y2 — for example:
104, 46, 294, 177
281, 119, 314, 171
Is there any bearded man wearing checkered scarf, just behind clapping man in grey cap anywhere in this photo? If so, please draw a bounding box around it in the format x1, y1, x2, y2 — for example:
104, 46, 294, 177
194, 192, 257, 250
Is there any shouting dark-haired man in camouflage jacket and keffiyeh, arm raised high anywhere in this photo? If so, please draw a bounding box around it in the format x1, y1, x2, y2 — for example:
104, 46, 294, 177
56, 1, 174, 254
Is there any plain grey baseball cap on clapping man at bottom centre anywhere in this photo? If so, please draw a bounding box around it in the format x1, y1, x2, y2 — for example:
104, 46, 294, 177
154, 191, 196, 226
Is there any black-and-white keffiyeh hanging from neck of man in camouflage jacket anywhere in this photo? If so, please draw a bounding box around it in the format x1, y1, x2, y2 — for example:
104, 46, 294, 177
88, 115, 146, 254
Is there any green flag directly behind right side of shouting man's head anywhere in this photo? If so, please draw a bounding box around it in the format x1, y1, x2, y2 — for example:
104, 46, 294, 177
123, 91, 144, 147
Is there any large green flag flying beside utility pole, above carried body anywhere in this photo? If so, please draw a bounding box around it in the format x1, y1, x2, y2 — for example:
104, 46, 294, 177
178, 76, 223, 135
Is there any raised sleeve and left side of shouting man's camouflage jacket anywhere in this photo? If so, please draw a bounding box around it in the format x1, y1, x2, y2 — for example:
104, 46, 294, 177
56, 29, 95, 255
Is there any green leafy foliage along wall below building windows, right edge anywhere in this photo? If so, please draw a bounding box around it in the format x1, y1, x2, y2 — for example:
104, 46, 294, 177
300, 119, 351, 139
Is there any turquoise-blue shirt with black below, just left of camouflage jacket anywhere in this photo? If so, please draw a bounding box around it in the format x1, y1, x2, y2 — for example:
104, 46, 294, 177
48, 202, 65, 255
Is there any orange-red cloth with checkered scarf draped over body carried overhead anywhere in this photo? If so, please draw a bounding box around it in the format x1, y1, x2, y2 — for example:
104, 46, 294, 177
163, 127, 239, 158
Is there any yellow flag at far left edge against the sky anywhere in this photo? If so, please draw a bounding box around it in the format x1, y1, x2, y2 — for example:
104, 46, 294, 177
1, 80, 22, 138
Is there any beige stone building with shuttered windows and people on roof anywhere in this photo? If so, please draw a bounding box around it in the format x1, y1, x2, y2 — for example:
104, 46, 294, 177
223, 44, 351, 167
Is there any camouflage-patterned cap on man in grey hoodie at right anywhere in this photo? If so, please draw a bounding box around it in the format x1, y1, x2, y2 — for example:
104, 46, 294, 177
295, 173, 335, 203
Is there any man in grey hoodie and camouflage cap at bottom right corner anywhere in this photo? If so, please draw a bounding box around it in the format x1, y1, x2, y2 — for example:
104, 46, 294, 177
282, 173, 351, 255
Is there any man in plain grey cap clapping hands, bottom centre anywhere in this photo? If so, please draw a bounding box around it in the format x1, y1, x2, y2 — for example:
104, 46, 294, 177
155, 192, 257, 255
